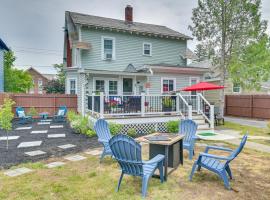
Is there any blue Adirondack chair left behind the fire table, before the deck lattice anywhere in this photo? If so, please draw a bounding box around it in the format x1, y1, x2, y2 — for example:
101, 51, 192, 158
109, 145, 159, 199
94, 119, 112, 161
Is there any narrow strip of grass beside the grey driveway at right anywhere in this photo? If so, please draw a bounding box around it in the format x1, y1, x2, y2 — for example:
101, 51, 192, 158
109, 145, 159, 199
221, 122, 270, 136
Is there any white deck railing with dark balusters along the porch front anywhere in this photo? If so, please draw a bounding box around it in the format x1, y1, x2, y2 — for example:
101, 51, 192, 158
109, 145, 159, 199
87, 92, 192, 119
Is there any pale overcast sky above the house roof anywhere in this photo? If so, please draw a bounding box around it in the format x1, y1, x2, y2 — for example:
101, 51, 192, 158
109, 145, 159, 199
0, 0, 270, 66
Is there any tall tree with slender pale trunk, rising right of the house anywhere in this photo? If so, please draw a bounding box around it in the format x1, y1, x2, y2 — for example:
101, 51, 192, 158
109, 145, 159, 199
189, 0, 267, 115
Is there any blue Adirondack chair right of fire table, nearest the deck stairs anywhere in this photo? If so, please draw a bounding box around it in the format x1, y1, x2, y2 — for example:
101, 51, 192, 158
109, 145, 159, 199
179, 119, 198, 160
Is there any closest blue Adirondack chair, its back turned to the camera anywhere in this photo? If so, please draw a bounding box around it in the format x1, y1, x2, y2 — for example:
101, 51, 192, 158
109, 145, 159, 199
109, 134, 164, 197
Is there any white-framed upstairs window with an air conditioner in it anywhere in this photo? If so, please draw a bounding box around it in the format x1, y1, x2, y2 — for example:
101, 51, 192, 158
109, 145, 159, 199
101, 37, 115, 60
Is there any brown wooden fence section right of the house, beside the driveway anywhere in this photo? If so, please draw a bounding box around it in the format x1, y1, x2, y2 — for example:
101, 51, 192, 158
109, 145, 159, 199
225, 95, 270, 119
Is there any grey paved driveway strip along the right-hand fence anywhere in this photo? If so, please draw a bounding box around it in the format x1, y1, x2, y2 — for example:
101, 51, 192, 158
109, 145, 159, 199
224, 117, 268, 128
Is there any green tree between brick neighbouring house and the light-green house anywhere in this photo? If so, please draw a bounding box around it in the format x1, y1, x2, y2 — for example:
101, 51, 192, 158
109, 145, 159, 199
44, 64, 66, 94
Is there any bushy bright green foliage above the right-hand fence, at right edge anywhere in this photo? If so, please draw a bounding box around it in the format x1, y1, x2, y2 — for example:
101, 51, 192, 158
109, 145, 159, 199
230, 36, 270, 90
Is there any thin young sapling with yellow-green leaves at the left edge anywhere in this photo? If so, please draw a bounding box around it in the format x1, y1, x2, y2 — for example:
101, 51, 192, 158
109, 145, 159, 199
0, 98, 15, 149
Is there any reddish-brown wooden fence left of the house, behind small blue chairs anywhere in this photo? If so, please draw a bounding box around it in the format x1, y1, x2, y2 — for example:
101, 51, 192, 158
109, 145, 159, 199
0, 93, 77, 115
